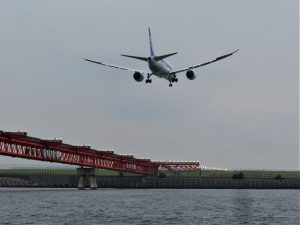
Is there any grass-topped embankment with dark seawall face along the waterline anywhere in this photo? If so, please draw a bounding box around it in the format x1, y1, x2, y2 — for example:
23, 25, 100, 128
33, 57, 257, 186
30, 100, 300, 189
0, 168, 300, 189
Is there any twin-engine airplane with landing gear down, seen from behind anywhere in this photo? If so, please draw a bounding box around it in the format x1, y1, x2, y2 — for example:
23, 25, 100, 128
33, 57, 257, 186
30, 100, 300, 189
82, 28, 239, 87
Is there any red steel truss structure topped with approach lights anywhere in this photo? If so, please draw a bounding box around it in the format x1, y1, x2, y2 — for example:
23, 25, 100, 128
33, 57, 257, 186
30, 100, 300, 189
0, 131, 200, 174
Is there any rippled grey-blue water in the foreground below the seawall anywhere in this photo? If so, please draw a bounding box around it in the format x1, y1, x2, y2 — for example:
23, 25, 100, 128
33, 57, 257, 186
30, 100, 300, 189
0, 188, 300, 225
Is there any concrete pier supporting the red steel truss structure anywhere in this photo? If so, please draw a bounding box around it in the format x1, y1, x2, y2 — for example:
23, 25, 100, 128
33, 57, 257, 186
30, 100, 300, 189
77, 167, 97, 190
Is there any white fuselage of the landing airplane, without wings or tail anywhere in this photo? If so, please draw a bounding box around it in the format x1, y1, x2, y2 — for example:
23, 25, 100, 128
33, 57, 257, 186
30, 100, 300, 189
148, 57, 175, 80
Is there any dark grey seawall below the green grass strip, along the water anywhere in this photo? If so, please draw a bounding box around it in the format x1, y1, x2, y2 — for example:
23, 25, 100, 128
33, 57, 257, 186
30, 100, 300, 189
0, 174, 300, 189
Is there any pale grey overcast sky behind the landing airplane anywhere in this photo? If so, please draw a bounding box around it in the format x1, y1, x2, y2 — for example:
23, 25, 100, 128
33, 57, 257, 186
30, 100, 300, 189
0, 0, 299, 169
